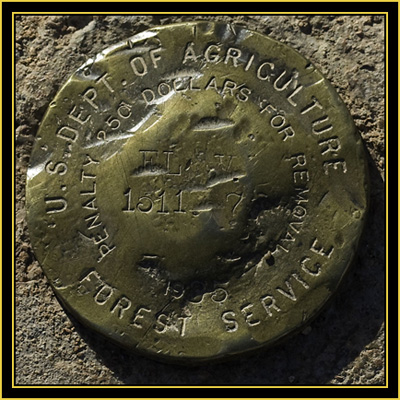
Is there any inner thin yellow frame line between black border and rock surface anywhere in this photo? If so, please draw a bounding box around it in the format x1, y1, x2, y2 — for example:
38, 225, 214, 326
11, 10, 388, 389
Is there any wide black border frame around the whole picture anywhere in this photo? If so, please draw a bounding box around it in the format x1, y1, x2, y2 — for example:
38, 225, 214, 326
2, 2, 399, 398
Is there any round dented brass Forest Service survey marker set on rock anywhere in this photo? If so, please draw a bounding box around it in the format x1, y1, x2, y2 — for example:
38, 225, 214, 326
27, 22, 367, 362
